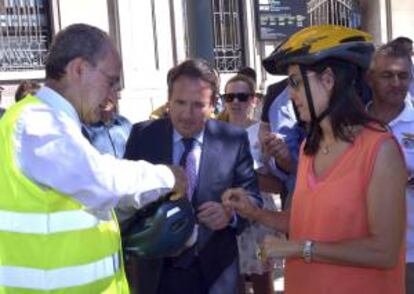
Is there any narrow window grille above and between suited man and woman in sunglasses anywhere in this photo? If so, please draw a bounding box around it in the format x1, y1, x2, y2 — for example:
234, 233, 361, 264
212, 0, 244, 72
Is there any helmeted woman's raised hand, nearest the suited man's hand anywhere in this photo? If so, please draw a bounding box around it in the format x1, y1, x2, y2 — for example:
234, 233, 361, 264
221, 188, 259, 219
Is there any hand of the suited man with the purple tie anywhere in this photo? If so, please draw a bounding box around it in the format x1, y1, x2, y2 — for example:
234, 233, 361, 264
197, 201, 233, 231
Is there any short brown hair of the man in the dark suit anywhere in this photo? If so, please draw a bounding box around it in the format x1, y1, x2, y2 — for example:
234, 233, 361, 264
167, 58, 219, 103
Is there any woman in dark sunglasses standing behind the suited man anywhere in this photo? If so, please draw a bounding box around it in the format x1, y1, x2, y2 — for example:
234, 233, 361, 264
219, 74, 276, 294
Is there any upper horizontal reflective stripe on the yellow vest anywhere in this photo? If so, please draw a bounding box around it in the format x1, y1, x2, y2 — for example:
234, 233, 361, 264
0, 210, 108, 234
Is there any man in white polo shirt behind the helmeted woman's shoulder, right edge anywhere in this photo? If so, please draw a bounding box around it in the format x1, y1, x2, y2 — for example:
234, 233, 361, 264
367, 42, 414, 294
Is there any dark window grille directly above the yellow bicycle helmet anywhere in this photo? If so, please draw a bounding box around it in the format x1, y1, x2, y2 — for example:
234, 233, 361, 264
308, 0, 361, 28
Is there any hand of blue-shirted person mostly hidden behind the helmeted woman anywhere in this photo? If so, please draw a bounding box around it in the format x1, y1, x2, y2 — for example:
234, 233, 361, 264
261, 133, 292, 172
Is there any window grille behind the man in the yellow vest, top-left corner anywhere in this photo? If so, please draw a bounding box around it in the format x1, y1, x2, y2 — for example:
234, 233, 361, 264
0, 0, 50, 71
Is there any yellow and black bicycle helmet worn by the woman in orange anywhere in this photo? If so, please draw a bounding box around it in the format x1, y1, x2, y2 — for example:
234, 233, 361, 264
263, 25, 374, 75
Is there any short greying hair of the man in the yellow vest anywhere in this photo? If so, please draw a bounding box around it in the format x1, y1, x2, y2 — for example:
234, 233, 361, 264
46, 24, 110, 80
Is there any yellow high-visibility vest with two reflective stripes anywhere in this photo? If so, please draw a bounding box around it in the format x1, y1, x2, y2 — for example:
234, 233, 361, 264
0, 96, 129, 294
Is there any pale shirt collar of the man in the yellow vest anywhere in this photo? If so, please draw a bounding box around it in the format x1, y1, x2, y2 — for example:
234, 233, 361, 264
36, 86, 82, 128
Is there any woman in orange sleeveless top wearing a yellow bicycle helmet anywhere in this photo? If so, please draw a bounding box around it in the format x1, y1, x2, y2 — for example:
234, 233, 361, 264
223, 25, 407, 294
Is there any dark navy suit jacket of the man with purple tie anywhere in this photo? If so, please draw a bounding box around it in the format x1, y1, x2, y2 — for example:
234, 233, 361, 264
125, 118, 261, 294
